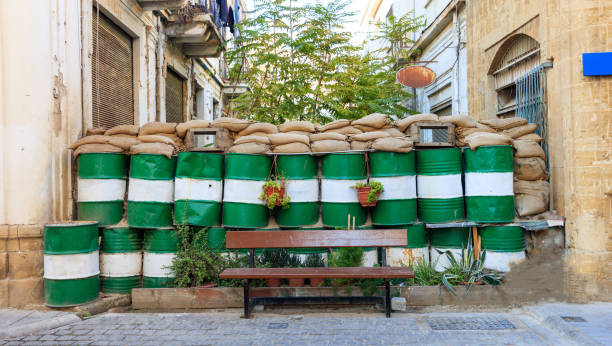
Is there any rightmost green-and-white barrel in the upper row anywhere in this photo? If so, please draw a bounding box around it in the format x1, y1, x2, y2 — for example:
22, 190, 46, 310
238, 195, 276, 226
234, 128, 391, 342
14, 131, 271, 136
464, 145, 514, 223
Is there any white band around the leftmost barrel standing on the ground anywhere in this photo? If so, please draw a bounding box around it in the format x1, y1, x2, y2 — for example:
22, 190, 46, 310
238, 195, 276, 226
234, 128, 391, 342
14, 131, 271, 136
44, 251, 100, 280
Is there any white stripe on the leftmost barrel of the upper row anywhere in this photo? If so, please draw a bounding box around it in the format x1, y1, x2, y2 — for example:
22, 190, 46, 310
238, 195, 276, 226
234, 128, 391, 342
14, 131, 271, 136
77, 179, 126, 202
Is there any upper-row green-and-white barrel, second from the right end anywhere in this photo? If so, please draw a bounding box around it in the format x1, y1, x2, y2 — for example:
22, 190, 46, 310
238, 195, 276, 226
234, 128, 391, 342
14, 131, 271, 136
416, 148, 464, 223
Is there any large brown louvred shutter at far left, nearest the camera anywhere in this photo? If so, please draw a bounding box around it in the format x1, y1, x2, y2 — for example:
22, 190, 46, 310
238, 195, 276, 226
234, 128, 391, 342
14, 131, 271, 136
91, 7, 134, 128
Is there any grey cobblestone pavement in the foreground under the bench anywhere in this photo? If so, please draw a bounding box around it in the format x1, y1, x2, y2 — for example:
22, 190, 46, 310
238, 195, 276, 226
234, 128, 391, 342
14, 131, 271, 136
0, 310, 588, 346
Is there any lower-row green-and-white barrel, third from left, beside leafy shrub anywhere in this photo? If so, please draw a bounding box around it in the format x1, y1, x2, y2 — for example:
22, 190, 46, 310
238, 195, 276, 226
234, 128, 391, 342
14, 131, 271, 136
142, 227, 180, 288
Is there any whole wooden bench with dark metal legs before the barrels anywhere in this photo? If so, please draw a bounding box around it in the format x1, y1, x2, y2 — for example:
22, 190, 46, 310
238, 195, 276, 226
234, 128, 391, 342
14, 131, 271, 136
220, 229, 414, 318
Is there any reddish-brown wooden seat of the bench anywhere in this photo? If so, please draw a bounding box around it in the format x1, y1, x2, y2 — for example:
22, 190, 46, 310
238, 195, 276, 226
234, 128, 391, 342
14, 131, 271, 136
220, 267, 414, 279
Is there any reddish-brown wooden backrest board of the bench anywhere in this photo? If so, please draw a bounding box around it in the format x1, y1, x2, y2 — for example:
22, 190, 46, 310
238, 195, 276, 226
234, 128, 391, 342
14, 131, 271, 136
225, 229, 408, 249
